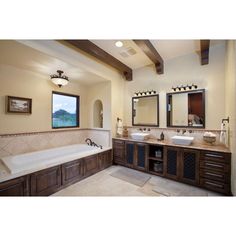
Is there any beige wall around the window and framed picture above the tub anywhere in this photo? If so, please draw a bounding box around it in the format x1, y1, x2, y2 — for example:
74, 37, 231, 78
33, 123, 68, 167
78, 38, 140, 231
0, 64, 87, 134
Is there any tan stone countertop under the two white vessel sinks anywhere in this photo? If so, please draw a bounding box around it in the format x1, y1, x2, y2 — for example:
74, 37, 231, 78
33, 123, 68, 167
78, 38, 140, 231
114, 137, 230, 153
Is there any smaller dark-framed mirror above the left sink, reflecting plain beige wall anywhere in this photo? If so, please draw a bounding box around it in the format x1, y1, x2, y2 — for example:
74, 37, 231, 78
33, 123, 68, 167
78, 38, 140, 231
132, 95, 159, 127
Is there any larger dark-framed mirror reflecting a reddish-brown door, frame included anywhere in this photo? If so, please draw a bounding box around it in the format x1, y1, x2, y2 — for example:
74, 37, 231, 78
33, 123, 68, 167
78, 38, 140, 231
166, 89, 205, 128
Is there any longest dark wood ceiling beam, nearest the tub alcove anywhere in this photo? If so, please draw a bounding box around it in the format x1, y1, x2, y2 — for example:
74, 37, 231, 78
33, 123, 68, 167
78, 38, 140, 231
64, 40, 132, 81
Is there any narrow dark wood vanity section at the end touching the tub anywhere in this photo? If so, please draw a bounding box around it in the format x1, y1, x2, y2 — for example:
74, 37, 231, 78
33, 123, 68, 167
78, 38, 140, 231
113, 139, 125, 165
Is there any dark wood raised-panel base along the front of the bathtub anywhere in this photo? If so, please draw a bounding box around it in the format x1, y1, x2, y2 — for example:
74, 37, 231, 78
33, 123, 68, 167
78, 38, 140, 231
0, 150, 112, 196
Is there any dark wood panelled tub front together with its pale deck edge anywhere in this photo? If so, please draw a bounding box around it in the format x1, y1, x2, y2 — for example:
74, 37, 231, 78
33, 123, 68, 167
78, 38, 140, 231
0, 148, 112, 196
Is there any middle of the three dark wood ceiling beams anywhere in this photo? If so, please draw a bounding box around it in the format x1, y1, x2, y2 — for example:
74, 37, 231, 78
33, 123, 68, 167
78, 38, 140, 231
133, 40, 164, 74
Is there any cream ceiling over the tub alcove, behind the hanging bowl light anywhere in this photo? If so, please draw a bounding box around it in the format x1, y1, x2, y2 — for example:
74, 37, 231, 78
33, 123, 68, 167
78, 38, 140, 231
0, 40, 106, 85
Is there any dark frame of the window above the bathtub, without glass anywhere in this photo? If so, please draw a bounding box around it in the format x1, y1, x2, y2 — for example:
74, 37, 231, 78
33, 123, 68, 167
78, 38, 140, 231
51, 91, 80, 129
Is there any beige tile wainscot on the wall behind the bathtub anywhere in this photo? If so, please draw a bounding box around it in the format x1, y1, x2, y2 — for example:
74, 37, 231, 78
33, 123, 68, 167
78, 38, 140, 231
0, 128, 111, 158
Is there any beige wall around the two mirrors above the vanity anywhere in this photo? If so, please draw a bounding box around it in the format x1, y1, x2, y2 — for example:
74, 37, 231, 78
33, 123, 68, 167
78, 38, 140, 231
124, 44, 225, 129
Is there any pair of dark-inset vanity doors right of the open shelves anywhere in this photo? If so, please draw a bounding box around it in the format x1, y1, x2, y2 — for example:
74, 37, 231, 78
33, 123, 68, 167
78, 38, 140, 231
164, 147, 200, 185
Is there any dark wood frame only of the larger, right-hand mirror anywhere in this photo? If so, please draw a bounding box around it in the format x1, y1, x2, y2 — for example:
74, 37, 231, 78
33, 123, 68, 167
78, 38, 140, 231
166, 89, 206, 129
